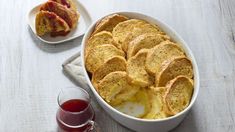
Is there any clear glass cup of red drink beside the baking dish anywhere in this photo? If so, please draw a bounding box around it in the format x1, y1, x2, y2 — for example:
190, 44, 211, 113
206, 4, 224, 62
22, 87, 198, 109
56, 87, 100, 132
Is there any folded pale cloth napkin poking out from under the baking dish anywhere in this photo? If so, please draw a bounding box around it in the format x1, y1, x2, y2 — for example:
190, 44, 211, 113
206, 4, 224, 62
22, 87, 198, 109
62, 52, 88, 88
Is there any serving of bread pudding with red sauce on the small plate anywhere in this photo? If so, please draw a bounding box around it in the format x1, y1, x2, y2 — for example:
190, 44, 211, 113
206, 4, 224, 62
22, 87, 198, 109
35, 0, 79, 37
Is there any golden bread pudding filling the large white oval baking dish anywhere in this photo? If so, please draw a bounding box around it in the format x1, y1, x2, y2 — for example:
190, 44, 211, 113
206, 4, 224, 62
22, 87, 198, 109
85, 14, 194, 119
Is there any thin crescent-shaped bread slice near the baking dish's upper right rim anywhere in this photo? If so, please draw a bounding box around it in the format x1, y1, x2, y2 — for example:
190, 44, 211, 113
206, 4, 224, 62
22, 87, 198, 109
122, 23, 170, 52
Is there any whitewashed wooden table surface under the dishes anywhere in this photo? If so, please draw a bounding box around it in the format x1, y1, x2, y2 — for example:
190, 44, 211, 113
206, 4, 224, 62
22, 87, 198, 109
0, 0, 235, 132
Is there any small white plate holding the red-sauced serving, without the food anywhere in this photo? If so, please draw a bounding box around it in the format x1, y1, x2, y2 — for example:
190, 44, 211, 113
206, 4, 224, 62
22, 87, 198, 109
28, 0, 92, 44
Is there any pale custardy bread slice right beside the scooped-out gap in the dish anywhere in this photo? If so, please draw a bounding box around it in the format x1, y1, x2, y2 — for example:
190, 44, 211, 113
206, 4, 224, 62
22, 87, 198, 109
143, 86, 167, 119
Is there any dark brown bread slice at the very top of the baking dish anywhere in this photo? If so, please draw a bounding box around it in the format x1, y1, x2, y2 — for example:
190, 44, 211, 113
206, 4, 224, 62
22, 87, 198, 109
93, 14, 128, 34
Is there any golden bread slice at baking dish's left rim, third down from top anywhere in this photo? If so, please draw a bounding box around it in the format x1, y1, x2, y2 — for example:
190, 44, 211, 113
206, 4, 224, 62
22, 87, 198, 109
85, 44, 125, 73
